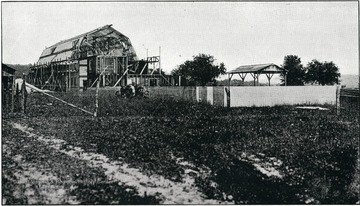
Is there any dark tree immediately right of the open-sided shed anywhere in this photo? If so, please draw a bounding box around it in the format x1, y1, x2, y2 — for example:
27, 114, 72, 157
280, 55, 305, 85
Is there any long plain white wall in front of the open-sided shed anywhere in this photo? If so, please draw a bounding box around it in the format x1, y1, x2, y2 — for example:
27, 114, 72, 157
229, 86, 337, 107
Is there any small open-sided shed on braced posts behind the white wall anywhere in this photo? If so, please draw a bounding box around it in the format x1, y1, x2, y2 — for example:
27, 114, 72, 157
228, 63, 287, 86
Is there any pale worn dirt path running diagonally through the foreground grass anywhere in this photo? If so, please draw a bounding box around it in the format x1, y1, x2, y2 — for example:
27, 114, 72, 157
11, 123, 231, 204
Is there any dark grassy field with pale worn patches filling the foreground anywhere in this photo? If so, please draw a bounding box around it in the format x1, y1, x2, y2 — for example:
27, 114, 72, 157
2, 91, 360, 204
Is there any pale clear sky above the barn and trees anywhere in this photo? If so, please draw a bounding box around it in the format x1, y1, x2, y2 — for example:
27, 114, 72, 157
2, 1, 359, 81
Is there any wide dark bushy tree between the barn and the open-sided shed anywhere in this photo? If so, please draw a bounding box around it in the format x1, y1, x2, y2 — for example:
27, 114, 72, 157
171, 54, 226, 86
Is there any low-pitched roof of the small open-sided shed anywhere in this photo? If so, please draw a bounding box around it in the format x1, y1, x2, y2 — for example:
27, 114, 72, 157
228, 63, 285, 74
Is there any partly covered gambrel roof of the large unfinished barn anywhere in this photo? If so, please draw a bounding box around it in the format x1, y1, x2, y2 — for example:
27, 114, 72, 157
38, 25, 137, 64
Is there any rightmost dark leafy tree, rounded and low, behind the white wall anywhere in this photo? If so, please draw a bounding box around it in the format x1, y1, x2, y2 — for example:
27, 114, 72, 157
306, 59, 340, 85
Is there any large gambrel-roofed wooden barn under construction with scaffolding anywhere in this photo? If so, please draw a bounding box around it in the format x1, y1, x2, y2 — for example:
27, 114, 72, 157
27, 25, 178, 91
